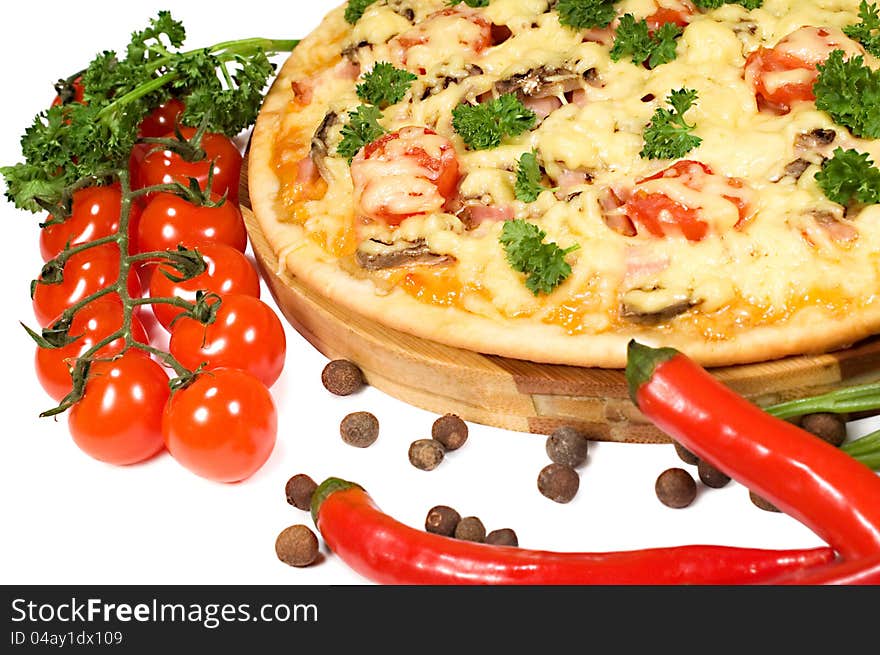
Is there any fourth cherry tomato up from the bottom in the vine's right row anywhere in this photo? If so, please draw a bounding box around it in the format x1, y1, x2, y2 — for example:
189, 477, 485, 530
137, 193, 247, 252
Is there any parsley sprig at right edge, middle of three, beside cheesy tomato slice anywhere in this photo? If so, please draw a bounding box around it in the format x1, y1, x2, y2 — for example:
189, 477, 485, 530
813, 50, 880, 139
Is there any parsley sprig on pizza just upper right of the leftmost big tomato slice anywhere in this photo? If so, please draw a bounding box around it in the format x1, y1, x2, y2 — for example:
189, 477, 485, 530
452, 93, 536, 150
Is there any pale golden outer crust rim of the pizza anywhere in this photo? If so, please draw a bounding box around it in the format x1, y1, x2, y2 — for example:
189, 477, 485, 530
248, 1, 880, 368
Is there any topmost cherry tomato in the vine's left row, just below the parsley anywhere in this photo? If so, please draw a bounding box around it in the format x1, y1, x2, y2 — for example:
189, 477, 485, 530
40, 185, 141, 261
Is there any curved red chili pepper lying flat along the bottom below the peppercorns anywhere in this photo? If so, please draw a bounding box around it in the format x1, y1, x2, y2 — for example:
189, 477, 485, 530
312, 478, 834, 585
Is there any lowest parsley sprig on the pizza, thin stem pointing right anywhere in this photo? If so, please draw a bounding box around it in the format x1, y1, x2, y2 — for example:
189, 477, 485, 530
499, 219, 580, 296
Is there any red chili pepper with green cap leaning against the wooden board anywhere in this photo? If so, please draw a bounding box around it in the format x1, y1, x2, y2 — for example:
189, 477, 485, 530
626, 341, 880, 560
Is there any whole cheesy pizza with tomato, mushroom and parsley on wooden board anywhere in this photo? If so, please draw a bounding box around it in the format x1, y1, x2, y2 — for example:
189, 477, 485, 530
249, 0, 880, 368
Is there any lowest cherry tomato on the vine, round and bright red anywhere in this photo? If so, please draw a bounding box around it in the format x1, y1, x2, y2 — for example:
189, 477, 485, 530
162, 368, 278, 482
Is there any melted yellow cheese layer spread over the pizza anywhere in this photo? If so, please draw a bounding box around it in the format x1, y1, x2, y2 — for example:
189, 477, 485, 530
276, 0, 880, 339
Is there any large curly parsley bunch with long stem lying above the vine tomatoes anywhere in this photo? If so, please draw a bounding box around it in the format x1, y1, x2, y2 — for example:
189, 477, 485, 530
0, 11, 298, 215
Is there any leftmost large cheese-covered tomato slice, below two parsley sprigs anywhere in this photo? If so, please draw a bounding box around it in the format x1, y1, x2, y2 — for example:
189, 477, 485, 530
351, 127, 459, 226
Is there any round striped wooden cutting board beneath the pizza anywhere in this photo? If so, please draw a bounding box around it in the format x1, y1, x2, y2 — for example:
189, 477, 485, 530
240, 170, 880, 443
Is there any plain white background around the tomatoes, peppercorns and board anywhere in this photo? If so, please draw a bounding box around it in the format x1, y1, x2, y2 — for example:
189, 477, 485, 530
0, 0, 867, 585
